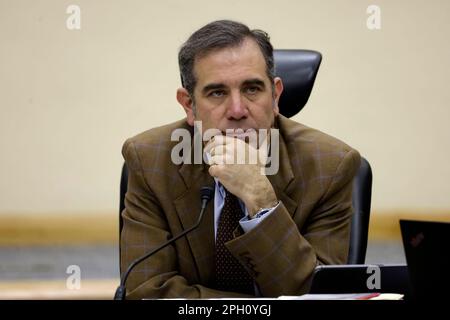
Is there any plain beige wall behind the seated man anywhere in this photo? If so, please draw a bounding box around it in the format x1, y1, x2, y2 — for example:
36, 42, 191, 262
0, 0, 450, 214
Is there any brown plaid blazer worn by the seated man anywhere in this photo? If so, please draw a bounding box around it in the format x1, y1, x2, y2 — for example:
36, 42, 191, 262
121, 116, 360, 299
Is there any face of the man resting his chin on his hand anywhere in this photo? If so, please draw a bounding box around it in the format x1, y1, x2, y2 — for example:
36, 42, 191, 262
178, 39, 283, 133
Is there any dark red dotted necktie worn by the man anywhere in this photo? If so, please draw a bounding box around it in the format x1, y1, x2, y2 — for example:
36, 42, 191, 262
215, 191, 255, 294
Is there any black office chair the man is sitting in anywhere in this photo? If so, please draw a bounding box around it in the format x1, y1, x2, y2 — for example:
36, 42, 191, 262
119, 50, 372, 264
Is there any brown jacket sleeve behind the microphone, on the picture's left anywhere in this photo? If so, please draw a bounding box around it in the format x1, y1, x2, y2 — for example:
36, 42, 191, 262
120, 140, 253, 299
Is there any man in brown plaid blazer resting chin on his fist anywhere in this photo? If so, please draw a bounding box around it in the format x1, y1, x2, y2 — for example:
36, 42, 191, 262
121, 21, 360, 299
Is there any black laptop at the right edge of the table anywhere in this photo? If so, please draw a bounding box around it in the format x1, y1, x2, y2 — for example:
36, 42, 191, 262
400, 220, 450, 300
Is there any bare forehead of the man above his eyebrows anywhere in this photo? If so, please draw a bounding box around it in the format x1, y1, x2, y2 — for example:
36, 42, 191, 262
194, 39, 268, 88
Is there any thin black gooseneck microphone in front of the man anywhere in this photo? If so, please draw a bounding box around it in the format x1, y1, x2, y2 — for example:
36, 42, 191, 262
114, 187, 214, 300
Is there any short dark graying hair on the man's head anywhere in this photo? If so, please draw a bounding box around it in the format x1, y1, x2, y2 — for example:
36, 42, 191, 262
178, 20, 275, 100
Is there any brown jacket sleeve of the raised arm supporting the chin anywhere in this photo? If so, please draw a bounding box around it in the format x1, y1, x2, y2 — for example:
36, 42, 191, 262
226, 150, 360, 297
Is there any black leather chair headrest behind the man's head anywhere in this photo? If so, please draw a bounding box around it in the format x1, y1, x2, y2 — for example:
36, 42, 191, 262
273, 49, 322, 118
